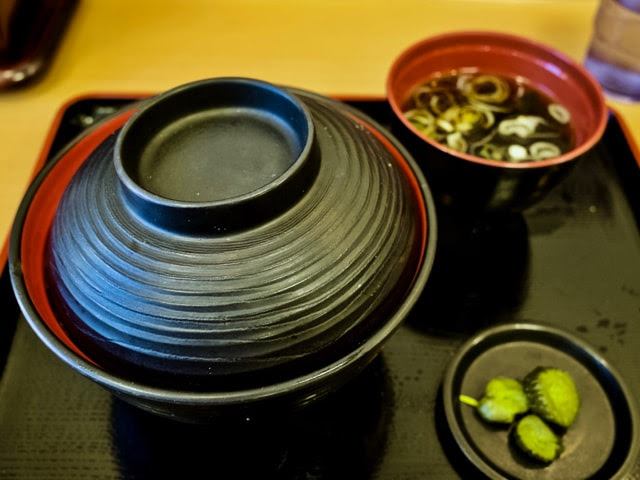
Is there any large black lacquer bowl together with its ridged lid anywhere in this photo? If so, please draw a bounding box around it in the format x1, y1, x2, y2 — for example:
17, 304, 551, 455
10, 78, 436, 420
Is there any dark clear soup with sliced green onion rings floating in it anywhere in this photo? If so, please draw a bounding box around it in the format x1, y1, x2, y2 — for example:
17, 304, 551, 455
403, 71, 575, 162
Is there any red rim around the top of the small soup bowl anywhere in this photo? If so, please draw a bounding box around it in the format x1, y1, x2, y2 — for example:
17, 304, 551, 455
386, 31, 608, 169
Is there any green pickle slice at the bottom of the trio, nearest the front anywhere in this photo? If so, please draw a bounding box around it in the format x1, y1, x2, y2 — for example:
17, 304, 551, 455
512, 414, 563, 463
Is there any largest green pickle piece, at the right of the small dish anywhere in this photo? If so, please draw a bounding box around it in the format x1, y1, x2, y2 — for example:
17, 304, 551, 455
523, 367, 580, 428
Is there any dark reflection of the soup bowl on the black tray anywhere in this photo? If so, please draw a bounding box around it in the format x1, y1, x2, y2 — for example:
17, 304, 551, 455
409, 214, 529, 334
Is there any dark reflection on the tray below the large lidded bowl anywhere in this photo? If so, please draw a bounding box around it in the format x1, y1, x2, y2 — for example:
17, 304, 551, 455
111, 358, 393, 479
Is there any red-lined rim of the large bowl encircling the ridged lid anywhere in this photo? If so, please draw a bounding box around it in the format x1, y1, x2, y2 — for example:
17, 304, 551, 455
9, 103, 436, 405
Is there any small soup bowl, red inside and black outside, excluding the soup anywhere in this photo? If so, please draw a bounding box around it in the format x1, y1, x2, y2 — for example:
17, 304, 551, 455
387, 32, 608, 213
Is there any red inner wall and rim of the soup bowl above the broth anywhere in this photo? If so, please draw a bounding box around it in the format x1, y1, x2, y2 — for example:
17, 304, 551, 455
387, 32, 608, 168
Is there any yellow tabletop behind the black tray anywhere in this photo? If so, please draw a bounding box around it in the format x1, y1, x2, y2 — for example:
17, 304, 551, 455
0, 0, 640, 248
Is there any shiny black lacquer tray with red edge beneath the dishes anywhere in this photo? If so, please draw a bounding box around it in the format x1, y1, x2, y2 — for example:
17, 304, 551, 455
0, 96, 640, 479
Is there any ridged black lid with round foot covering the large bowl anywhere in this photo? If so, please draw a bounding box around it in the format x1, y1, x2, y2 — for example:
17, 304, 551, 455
50, 79, 424, 386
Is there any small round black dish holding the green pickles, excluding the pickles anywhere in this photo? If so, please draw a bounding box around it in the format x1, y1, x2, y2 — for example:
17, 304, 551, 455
442, 323, 640, 480
